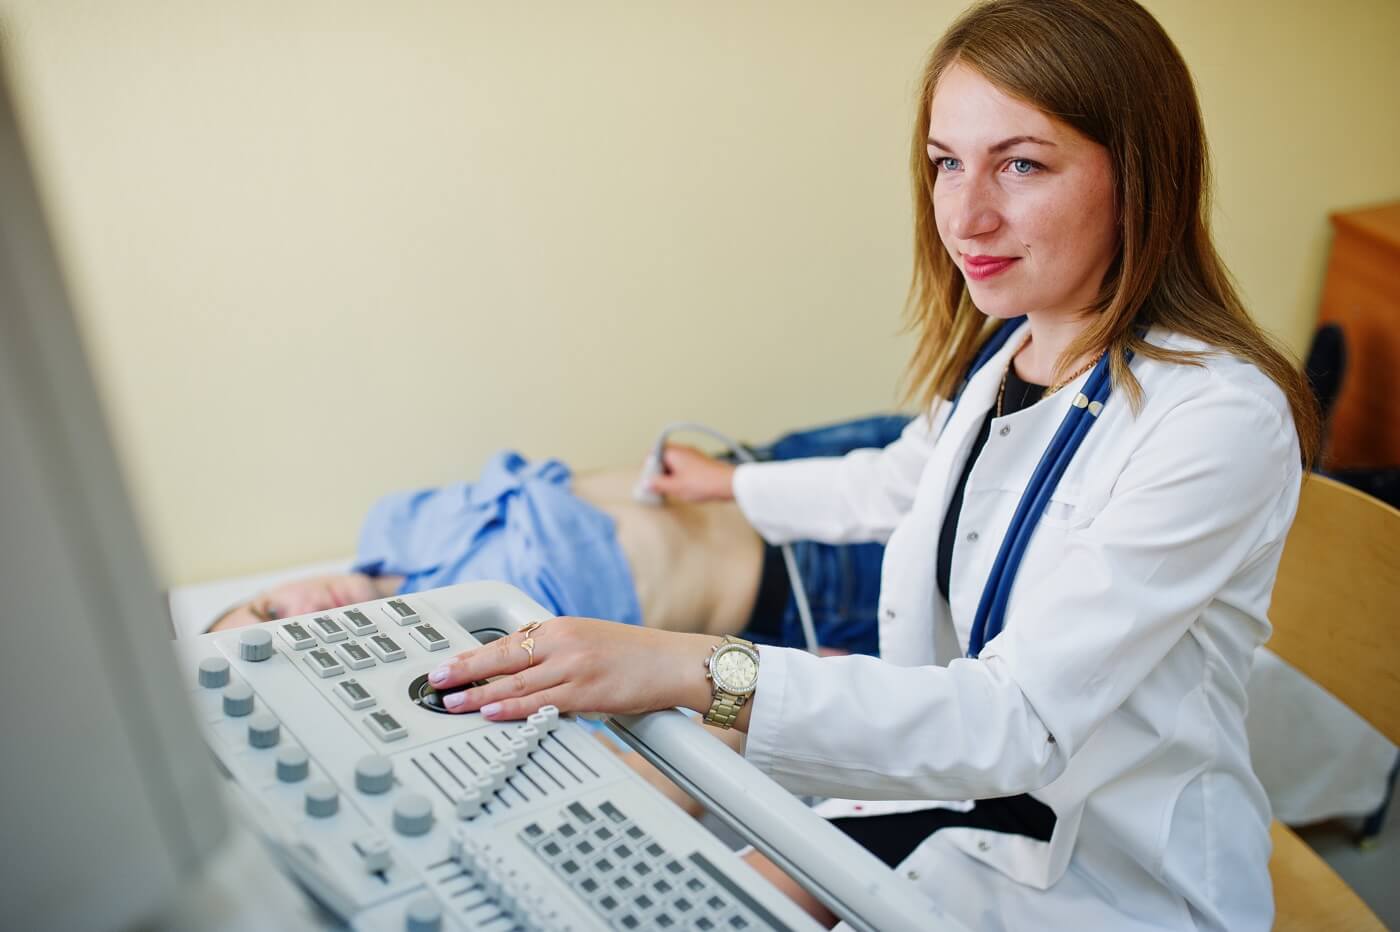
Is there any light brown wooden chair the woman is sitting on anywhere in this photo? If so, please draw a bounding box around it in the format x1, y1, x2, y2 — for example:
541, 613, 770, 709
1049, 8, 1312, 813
1267, 476, 1400, 932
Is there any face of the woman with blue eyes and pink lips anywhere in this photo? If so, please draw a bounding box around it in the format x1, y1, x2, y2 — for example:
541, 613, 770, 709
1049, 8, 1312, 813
928, 64, 1119, 318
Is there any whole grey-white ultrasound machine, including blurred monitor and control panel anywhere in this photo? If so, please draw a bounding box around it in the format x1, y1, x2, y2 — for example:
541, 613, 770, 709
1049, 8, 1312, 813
0, 59, 955, 932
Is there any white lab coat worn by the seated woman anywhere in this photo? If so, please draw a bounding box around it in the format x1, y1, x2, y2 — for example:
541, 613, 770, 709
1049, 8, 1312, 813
735, 326, 1302, 931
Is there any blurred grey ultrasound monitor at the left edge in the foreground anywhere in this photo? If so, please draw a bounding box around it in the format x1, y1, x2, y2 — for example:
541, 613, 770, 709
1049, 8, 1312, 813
0, 58, 227, 929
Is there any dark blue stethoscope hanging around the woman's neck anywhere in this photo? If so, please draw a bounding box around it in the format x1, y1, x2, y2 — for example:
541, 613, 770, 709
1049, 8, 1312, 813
944, 318, 1133, 658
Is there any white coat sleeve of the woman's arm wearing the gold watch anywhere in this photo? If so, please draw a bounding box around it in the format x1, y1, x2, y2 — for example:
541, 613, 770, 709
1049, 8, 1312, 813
745, 377, 1299, 799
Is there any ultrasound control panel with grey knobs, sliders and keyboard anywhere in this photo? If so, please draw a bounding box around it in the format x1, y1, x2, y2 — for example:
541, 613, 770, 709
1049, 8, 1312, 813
178, 584, 819, 932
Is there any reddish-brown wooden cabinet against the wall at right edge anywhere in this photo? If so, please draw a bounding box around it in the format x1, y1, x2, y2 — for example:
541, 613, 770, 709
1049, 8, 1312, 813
1317, 203, 1400, 469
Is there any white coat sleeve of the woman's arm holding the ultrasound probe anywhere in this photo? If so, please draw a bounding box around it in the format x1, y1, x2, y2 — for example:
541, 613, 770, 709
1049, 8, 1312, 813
734, 402, 948, 544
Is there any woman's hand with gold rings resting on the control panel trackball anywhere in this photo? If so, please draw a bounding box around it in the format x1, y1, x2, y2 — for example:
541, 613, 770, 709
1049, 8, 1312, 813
428, 616, 718, 721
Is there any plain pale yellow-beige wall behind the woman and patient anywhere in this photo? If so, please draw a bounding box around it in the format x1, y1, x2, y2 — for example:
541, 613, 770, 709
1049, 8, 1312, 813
0, 0, 1400, 582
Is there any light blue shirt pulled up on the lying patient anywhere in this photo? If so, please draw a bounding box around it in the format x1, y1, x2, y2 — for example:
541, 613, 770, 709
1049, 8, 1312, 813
354, 451, 641, 624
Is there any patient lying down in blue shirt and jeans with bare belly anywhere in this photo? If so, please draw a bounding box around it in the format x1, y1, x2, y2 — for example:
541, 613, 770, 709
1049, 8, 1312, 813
211, 417, 907, 814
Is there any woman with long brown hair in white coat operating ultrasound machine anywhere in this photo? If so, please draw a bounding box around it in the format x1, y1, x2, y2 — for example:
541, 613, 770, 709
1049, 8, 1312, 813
434, 0, 1317, 929
